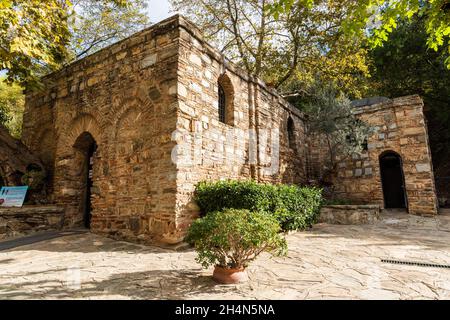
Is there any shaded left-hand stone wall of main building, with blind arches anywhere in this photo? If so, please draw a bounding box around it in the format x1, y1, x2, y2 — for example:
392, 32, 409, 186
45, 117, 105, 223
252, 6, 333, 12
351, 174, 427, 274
23, 19, 179, 244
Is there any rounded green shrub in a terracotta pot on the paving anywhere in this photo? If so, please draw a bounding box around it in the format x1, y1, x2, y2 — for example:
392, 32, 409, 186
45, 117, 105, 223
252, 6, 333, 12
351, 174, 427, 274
186, 209, 287, 284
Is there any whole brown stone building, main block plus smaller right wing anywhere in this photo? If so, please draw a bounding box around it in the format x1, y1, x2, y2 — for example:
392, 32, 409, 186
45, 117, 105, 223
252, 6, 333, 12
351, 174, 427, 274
19, 15, 436, 243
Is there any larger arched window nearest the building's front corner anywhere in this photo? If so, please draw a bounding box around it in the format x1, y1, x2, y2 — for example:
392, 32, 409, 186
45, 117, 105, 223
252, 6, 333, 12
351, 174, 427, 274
217, 73, 234, 126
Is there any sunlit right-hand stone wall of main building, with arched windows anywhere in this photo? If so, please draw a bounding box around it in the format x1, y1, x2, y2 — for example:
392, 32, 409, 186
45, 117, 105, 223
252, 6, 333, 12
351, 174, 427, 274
175, 20, 306, 238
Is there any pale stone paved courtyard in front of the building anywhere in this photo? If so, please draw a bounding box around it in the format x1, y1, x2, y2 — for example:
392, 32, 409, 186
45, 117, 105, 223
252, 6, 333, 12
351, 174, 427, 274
0, 213, 450, 299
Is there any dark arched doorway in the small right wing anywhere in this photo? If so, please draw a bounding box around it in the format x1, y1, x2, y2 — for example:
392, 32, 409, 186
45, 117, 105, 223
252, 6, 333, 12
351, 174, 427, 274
380, 151, 408, 209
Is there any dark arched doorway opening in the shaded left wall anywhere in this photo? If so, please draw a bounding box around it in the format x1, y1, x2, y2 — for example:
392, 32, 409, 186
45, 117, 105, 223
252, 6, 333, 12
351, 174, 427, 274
73, 132, 97, 229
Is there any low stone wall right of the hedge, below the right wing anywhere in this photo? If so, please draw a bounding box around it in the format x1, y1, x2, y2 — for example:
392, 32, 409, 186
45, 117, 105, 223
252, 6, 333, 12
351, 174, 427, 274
319, 205, 380, 225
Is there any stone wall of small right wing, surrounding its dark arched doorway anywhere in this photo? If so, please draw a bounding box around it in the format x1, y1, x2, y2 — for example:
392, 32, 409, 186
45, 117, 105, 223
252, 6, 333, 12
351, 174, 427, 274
311, 96, 437, 214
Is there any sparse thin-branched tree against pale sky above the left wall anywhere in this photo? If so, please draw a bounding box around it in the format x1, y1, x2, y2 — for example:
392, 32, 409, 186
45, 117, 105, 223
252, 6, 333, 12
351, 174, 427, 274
69, 0, 150, 61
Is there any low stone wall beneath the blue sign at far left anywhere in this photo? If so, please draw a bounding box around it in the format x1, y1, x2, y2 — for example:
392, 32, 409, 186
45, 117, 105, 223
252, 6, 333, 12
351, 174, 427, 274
0, 206, 64, 240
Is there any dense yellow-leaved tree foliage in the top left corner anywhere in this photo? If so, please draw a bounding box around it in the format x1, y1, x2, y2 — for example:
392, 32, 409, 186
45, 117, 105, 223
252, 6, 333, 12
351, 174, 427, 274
0, 0, 131, 85
